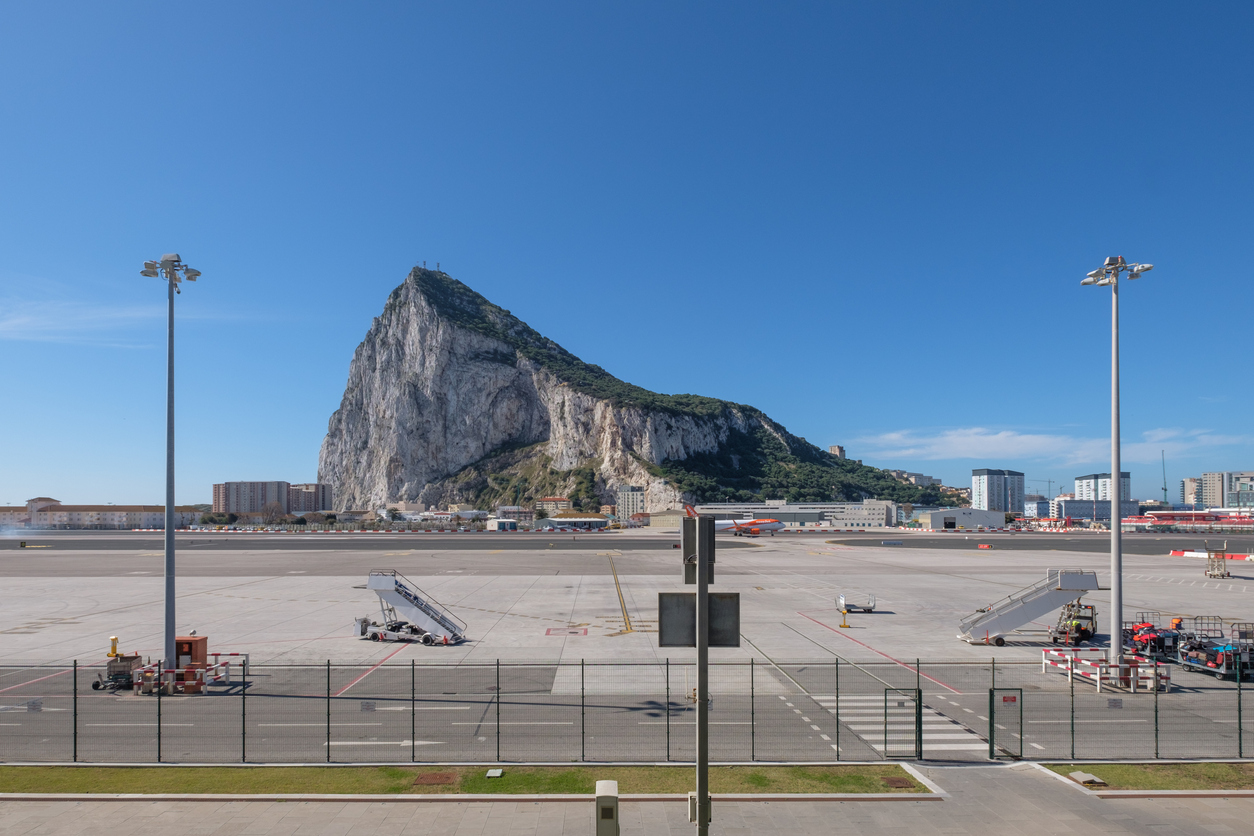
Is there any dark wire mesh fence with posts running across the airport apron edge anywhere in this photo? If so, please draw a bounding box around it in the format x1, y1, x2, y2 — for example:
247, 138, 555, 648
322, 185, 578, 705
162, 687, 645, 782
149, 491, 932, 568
0, 659, 1254, 763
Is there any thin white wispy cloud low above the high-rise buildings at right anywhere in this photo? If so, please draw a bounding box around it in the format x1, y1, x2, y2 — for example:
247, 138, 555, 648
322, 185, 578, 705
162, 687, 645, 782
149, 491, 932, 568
856, 426, 1254, 465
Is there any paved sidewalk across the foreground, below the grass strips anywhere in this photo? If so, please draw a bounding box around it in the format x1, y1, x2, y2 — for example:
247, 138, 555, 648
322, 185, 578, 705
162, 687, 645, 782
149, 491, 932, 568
0, 763, 1254, 836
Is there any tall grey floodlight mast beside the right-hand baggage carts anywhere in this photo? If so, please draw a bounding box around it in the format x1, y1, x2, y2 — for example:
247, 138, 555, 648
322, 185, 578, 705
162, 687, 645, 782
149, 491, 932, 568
1080, 256, 1154, 664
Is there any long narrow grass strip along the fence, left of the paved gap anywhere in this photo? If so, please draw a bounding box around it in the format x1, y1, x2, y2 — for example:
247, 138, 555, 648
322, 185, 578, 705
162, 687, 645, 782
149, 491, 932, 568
0, 763, 928, 796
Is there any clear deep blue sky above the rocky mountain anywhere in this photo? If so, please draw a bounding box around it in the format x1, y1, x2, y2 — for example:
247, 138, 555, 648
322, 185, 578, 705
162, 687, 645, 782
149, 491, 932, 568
0, 1, 1254, 504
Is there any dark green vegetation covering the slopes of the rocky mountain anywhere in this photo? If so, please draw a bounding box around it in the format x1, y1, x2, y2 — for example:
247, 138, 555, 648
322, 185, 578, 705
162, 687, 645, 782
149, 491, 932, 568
401, 267, 954, 510
